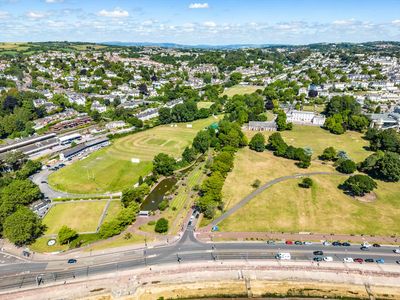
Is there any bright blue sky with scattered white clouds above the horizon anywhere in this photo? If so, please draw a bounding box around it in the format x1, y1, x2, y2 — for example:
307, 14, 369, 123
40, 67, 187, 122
0, 0, 400, 45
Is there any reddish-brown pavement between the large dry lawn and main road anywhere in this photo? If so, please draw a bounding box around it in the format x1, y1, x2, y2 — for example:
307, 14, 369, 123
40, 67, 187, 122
196, 231, 400, 245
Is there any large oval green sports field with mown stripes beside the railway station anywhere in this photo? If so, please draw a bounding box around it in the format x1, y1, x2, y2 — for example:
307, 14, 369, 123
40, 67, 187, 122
49, 117, 219, 194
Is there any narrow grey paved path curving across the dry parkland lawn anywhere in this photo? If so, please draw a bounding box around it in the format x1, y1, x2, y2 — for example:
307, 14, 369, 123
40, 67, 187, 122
211, 172, 342, 226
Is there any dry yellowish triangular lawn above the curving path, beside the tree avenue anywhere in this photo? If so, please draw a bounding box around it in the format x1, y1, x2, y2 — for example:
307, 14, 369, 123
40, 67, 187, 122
222, 148, 335, 209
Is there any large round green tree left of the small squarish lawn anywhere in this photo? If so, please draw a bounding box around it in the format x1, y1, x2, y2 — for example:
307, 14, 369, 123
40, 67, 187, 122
3, 206, 44, 246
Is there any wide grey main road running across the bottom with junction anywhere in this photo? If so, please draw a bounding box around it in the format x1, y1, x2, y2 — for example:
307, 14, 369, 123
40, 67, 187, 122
0, 216, 400, 291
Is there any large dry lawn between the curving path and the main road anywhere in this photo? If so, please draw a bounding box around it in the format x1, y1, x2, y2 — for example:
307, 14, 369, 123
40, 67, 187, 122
220, 175, 400, 236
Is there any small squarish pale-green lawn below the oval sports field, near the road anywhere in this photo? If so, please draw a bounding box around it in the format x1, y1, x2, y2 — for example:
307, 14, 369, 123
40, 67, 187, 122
43, 200, 107, 235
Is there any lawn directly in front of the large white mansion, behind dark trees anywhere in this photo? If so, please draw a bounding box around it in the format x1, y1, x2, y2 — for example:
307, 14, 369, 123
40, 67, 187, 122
246, 125, 372, 162
